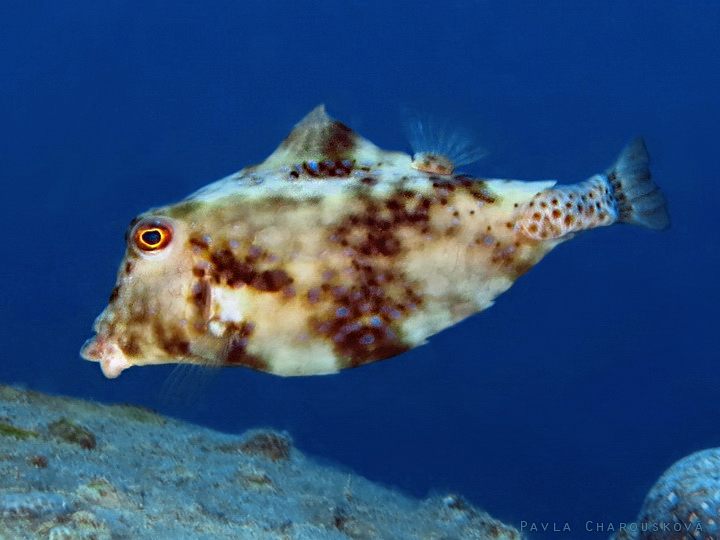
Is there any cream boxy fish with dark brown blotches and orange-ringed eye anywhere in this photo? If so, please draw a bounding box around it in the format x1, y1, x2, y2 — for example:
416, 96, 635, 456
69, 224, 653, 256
80, 105, 670, 378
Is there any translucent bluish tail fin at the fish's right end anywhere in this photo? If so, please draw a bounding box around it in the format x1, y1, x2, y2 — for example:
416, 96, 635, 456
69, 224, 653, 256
605, 137, 670, 231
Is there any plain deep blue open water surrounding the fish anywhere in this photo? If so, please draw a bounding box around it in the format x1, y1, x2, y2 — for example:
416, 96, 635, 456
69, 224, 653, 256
0, 0, 720, 538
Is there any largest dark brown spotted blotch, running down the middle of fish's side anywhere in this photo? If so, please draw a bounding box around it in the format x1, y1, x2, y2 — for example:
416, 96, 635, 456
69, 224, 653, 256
307, 189, 450, 367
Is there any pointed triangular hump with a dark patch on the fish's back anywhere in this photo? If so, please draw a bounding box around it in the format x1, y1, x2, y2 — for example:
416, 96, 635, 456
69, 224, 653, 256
253, 105, 408, 170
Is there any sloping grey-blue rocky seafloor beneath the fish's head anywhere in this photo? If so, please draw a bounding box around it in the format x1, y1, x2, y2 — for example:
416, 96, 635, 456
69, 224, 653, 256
0, 386, 522, 540
